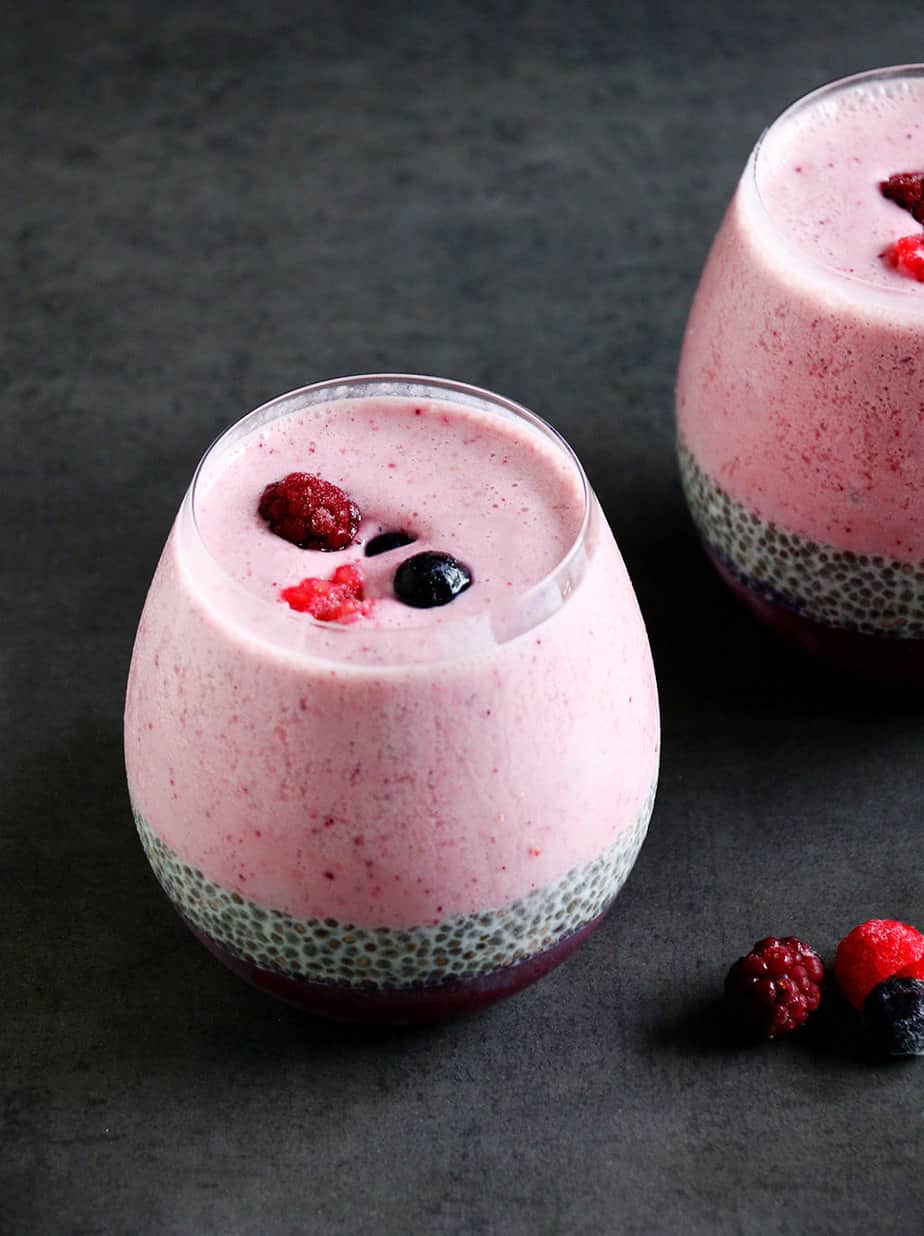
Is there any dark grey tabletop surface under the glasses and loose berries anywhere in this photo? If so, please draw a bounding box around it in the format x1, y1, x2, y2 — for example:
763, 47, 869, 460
0, 0, 924, 1236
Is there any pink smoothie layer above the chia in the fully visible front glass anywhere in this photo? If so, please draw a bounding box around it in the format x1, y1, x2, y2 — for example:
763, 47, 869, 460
126, 380, 658, 928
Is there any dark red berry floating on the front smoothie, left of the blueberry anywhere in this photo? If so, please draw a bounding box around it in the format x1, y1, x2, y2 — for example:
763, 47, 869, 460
258, 472, 362, 550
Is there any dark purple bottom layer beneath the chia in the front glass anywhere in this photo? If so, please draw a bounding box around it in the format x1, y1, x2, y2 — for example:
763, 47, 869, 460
187, 915, 604, 1026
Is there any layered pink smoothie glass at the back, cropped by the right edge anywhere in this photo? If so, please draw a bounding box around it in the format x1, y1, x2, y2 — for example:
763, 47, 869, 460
677, 66, 924, 684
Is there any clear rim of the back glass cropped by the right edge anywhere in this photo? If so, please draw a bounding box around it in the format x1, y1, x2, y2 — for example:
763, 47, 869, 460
742, 62, 924, 313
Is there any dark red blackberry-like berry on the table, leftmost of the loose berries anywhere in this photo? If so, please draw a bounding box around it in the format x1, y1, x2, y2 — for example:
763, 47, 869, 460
725, 936, 824, 1038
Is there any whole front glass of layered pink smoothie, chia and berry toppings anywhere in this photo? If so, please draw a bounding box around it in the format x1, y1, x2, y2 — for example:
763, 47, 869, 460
125, 375, 658, 1022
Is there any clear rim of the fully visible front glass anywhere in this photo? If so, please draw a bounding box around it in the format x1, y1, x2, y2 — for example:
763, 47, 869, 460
180, 373, 592, 669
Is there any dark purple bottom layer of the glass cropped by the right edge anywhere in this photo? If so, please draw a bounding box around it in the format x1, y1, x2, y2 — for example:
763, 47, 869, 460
707, 546, 924, 687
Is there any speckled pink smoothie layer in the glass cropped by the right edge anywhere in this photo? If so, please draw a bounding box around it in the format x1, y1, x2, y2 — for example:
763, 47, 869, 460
678, 62, 924, 562
